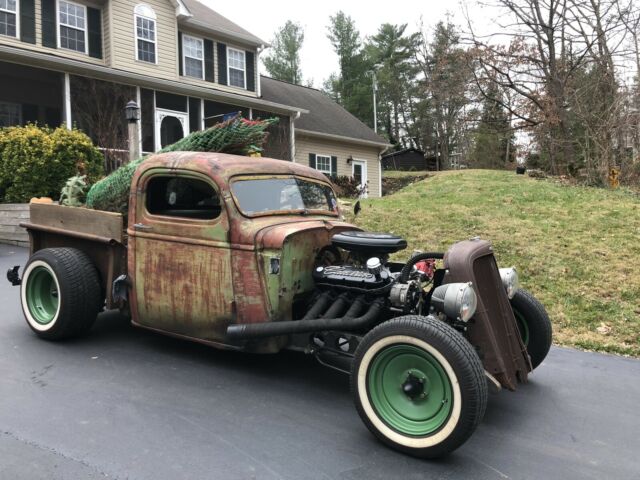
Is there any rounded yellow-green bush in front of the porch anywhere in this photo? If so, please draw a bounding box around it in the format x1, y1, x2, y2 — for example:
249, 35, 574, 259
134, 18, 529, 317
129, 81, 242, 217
0, 125, 103, 203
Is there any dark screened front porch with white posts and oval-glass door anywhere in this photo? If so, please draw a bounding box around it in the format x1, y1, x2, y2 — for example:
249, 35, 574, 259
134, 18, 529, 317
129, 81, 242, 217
0, 62, 293, 172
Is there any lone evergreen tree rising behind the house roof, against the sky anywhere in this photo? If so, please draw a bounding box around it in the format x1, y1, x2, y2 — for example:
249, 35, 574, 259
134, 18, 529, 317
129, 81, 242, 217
263, 20, 304, 85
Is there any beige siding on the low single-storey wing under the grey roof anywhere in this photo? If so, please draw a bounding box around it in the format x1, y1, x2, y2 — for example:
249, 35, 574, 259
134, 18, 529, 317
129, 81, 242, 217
295, 132, 380, 197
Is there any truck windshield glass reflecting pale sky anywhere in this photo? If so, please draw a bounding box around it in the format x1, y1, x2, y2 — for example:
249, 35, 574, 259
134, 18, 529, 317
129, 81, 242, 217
231, 177, 338, 216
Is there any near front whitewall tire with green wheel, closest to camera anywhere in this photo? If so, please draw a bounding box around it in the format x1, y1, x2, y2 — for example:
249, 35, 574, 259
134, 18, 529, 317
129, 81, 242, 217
351, 315, 488, 458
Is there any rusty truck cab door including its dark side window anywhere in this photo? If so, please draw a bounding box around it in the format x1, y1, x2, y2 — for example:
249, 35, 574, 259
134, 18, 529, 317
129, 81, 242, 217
129, 169, 233, 341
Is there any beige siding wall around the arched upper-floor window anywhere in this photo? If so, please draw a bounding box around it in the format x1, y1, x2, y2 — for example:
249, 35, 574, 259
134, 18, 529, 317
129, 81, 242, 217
111, 0, 178, 80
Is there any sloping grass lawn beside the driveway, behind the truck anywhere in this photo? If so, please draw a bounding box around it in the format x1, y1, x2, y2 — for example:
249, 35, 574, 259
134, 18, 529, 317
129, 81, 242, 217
350, 170, 640, 356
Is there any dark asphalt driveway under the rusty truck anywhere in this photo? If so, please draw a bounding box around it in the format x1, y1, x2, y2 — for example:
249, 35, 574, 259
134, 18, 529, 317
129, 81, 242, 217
0, 245, 640, 480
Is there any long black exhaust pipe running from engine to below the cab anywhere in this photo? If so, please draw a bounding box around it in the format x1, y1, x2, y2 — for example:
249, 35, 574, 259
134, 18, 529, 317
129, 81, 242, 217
227, 296, 384, 340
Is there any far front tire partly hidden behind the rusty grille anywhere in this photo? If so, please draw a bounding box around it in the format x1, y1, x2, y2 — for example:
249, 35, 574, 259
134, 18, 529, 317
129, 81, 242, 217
511, 289, 553, 368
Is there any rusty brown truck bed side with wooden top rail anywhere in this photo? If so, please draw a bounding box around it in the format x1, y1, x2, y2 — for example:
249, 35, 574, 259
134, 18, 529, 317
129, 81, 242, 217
20, 203, 127, 308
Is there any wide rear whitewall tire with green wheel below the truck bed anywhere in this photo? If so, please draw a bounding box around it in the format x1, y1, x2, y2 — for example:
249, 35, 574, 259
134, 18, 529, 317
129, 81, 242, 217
20, 248, 102, 340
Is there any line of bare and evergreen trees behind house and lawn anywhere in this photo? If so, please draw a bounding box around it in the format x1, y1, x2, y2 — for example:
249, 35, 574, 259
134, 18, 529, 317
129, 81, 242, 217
264, 0, 640, 185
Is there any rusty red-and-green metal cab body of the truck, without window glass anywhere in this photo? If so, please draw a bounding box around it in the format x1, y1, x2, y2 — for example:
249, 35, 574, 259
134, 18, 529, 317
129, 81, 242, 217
127, 152, 357, 352
